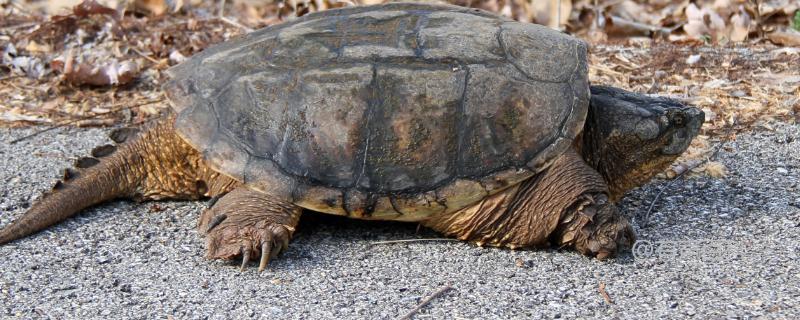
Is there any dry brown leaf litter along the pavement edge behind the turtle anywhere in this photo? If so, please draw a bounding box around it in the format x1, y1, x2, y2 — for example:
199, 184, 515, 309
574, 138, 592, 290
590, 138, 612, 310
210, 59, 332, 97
0, 0, 800, 178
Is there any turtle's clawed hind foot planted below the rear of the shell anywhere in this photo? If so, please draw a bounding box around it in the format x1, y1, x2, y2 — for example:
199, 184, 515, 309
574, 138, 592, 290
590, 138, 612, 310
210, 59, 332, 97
198, 187, 302, 271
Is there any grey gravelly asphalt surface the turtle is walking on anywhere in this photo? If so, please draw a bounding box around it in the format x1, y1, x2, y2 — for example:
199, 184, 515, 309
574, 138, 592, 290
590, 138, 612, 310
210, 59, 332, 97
0, 124, 800, 319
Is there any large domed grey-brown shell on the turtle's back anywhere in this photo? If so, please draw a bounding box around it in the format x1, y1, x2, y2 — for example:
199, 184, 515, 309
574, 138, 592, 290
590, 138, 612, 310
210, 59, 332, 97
164, 3, 589, 221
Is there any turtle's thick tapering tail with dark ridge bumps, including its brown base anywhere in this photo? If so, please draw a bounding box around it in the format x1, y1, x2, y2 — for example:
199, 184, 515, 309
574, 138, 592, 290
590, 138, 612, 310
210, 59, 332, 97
0, 116, 234, 245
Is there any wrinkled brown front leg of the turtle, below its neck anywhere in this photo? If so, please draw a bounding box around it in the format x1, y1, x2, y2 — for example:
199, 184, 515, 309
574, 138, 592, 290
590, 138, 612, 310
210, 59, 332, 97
423, 149, 635, 259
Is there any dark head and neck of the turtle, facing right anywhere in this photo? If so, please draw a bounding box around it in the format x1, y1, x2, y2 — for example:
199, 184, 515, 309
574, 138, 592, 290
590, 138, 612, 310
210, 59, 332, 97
581, 86, 705, 201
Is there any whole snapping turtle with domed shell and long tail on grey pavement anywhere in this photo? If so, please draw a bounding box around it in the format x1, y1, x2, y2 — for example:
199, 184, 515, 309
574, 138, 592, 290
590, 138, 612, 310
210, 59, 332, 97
0, 3, 703, 270
